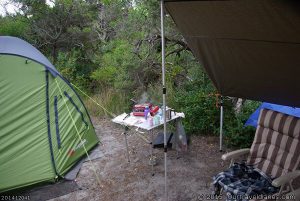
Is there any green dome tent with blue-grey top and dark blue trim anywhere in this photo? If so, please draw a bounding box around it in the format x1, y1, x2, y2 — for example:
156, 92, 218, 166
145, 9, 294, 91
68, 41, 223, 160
0, 36, 99, 192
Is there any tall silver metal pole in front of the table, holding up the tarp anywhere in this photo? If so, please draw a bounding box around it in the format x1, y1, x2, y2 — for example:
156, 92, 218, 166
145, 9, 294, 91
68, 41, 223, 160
160, 0, 168, 201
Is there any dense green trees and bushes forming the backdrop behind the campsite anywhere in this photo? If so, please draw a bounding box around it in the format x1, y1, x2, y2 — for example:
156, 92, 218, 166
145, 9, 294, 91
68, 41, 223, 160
0, 0, 257, 146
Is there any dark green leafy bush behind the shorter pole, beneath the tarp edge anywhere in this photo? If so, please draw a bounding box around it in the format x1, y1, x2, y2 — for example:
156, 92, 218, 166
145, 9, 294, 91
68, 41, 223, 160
175, 70, 260, 147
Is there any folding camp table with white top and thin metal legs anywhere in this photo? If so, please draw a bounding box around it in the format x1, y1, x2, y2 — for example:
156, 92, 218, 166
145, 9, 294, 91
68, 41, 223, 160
112, 111, 184, 175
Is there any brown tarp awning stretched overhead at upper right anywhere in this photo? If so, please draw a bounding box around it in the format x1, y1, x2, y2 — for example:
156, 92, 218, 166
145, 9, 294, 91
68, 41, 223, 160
165, 0, 300, 107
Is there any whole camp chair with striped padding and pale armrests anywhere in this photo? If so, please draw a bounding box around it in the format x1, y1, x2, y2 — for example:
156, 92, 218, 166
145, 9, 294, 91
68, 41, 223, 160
213, 109, 300, 200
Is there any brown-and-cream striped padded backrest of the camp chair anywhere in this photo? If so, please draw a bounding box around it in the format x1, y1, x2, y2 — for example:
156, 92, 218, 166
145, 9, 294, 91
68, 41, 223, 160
247, 109, 300, 178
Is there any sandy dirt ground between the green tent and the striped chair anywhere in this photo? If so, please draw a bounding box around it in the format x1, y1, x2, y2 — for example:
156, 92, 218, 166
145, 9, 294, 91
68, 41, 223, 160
52, 118, 300, 201
